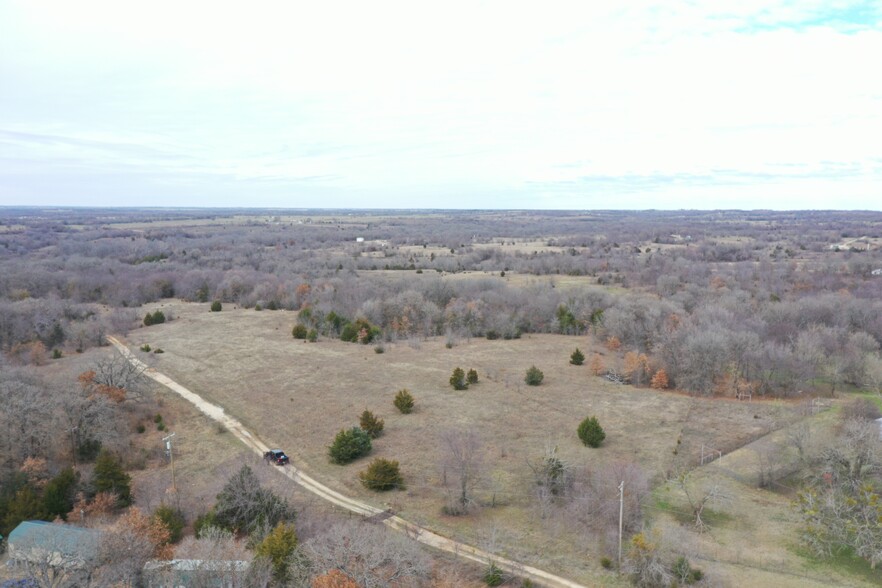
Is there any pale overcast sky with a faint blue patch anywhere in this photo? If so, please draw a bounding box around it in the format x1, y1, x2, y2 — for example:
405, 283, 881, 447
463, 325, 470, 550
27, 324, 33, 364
0, 0, 882, 210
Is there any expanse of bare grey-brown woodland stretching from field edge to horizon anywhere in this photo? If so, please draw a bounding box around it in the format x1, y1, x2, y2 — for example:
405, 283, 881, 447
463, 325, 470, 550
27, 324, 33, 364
0, 209, 882, 394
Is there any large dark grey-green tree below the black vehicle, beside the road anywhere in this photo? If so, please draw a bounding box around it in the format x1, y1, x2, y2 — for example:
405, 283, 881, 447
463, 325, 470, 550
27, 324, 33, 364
211, 465, 297, 534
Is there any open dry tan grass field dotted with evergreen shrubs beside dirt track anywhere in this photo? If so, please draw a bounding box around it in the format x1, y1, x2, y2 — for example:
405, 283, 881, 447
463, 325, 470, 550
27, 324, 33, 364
99, 302, 876, 585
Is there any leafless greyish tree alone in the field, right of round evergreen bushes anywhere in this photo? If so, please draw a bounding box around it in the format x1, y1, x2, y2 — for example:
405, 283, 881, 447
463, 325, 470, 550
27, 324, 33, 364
440, 429, 485, 515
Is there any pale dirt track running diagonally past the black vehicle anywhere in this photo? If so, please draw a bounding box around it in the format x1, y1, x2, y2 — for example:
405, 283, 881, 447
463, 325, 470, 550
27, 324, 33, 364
107, 336, 584, 588
